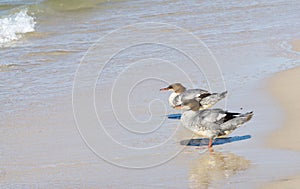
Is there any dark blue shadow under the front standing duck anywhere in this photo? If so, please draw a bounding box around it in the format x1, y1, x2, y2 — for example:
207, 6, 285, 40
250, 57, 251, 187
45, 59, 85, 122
180, 135, 251, 146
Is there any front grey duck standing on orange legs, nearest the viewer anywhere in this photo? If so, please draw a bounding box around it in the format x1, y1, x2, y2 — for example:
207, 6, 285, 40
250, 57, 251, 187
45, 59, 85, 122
180, 99, 253, 148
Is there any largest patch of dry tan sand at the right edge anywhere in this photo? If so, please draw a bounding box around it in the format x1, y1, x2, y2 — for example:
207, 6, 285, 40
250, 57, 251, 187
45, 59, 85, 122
270, 68, 300, 151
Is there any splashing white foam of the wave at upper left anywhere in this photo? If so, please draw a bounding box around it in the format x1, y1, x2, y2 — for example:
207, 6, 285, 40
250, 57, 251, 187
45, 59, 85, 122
0, 9, 35, 46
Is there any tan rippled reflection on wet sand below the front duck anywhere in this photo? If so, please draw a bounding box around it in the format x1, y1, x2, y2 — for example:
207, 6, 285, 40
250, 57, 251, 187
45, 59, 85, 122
189, 152, 250, 189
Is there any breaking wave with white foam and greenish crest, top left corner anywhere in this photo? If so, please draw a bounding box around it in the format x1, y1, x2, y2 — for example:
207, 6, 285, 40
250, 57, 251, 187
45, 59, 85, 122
0, 0, 122, 48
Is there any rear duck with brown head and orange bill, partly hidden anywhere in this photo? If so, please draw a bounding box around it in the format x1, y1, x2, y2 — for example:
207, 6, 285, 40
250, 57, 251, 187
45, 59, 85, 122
160, 83, 227, 110
